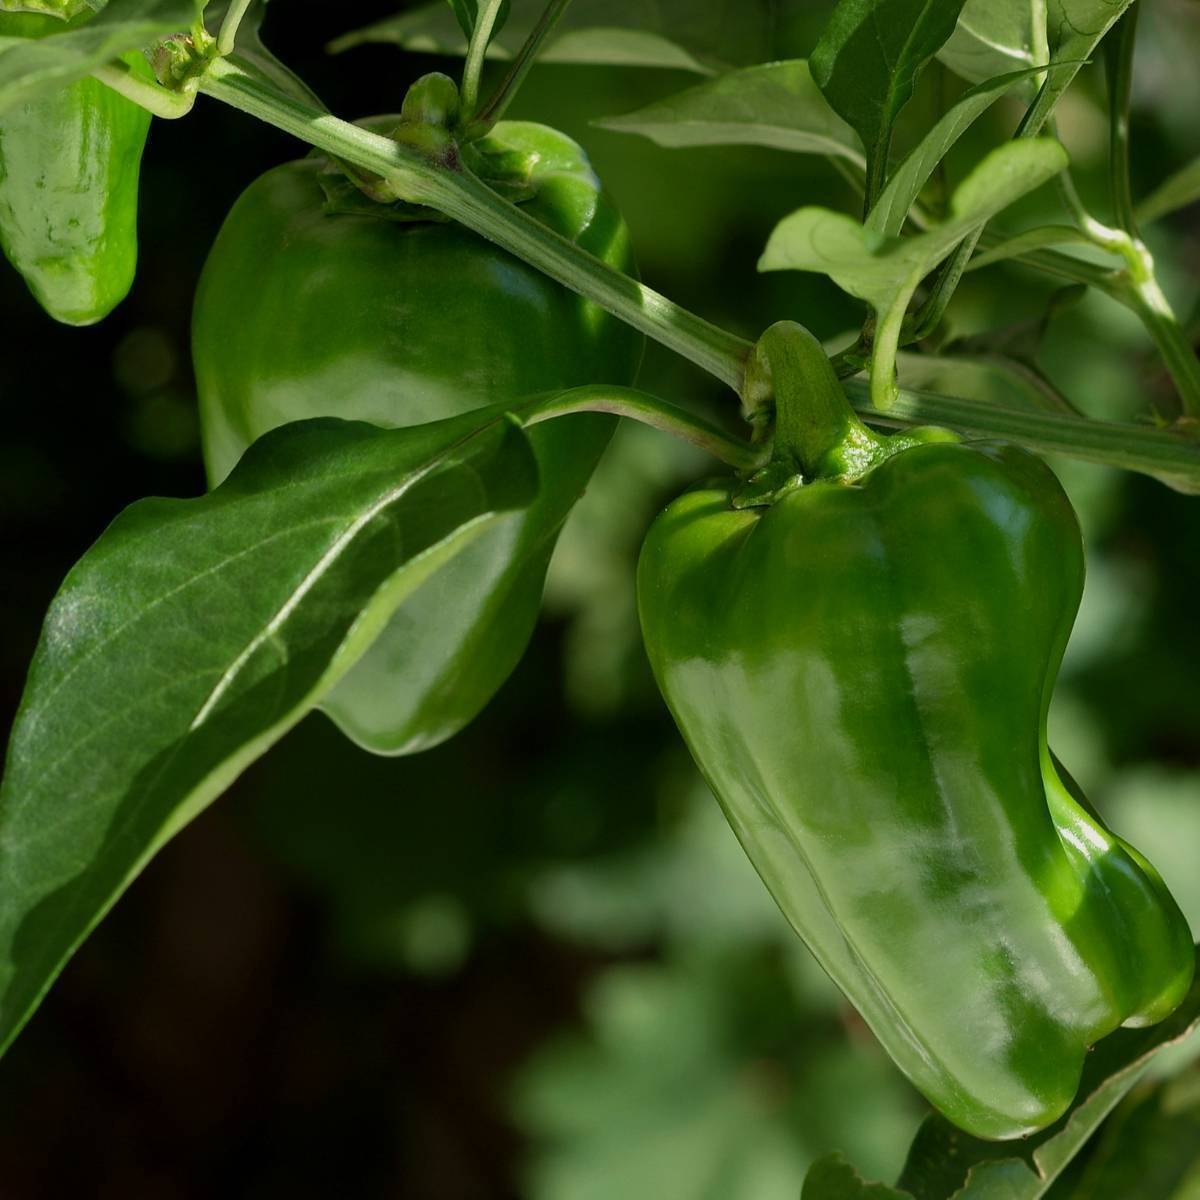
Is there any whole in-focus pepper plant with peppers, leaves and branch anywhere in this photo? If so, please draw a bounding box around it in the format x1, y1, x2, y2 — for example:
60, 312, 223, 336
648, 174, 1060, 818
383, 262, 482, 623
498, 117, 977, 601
0, 0, 1200, 1185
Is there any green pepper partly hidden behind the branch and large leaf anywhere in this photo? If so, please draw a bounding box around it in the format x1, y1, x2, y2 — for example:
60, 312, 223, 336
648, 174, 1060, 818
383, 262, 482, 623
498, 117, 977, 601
193, 121, 643, 754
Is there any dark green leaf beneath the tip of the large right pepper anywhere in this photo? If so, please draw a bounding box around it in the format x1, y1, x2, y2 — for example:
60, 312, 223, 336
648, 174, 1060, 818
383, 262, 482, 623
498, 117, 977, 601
802, 950, 1200, 1200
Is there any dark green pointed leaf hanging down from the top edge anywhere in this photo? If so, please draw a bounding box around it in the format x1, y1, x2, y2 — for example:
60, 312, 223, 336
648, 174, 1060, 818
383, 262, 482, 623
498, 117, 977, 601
809, 0, 962, 179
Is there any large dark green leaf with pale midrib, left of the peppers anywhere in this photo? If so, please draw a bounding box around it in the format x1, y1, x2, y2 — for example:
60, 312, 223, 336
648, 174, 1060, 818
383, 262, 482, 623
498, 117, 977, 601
0, 412, 536, 1049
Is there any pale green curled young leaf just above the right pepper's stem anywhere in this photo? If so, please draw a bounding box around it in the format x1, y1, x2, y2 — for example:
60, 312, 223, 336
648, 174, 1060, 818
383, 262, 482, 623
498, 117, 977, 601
758, 138, 1067, 409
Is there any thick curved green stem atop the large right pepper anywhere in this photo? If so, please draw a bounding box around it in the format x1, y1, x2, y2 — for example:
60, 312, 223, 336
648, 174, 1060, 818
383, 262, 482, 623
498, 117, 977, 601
745, 320, 881, 479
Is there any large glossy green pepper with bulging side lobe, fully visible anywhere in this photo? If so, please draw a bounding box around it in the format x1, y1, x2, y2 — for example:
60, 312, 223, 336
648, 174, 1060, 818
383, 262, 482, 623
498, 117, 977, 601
638, 442, 1193, 1139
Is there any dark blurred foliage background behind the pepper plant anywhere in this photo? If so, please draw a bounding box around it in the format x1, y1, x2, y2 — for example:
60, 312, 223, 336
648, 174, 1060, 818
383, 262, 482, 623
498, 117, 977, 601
0, 0, 1200, 1200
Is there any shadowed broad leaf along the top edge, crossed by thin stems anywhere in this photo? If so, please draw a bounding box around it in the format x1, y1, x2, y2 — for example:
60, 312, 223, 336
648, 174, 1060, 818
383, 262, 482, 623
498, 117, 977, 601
330, 0, 782, 74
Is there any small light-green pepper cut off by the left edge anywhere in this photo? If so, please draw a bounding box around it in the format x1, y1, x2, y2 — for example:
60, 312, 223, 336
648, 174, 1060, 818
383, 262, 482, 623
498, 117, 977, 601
0, 13, 152, 325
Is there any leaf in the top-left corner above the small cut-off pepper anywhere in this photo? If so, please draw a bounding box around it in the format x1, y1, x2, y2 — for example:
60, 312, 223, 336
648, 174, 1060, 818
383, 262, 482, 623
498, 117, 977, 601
0, 0, 200, 113
